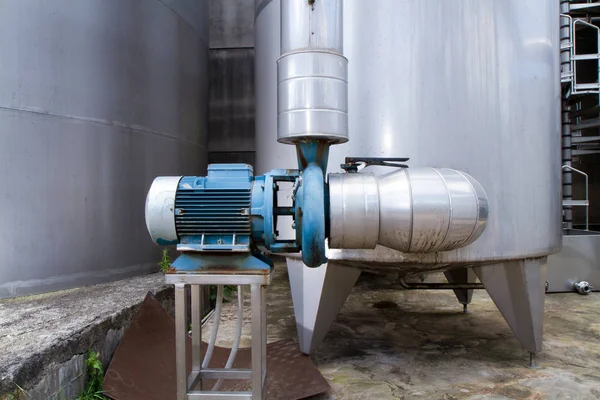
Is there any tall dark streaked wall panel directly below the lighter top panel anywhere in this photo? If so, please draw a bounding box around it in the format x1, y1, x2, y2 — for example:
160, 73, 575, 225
208, 49, 255, 152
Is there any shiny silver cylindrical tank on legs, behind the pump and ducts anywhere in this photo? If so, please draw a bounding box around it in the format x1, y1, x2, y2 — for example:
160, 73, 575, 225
255, 0, 561, 269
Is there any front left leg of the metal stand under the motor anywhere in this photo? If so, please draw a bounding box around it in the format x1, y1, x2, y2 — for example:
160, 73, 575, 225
175, 283, 187, 400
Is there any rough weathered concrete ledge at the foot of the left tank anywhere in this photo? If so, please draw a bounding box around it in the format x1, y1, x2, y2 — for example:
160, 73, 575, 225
0, 273, 173, 400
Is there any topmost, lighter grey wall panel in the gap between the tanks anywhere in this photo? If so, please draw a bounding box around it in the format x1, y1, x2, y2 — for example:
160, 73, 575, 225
209, 0, 254, 49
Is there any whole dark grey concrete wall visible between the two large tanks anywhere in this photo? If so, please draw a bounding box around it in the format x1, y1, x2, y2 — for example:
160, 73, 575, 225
208, 0, 255, 165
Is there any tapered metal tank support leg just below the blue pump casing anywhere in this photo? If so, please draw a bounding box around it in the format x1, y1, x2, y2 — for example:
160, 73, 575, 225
287, 258, 360, 354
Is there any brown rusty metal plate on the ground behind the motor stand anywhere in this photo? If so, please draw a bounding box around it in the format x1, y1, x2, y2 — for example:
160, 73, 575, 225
104, 294, 329, 400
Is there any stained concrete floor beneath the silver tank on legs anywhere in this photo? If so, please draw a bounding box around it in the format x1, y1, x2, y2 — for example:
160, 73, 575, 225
205, 263, 600, 400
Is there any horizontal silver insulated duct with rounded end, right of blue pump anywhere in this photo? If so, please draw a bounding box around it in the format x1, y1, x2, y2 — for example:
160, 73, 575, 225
329, 168, 488, 253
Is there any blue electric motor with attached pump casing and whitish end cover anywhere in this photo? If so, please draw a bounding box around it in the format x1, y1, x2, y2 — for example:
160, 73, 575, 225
146, 164, 326, 267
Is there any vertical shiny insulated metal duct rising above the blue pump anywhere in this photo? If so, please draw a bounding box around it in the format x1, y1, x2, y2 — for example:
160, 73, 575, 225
277, 0, 348, 143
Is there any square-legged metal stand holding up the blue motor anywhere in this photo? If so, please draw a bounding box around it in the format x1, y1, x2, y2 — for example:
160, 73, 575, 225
165, 269, 271, 400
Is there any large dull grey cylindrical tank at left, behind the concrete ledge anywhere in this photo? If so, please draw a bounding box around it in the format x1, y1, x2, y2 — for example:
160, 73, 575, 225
0, 0, 208, 297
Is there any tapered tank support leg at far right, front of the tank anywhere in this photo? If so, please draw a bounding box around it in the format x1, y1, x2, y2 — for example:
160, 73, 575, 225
473, 257, 546, 353
